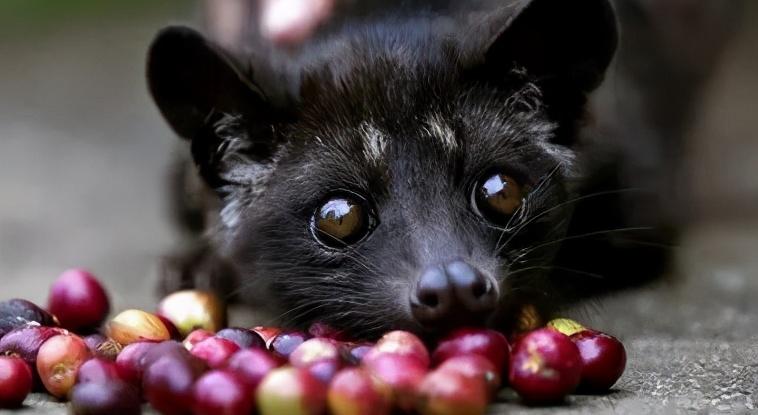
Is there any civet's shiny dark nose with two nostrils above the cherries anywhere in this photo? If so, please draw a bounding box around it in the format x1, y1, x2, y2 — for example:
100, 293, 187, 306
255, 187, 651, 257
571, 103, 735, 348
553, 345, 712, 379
410, 260, 498, 327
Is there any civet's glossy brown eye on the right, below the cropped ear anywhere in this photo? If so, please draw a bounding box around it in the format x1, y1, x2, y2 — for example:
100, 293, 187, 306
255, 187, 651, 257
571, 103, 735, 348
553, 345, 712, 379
473, 173, 524, 225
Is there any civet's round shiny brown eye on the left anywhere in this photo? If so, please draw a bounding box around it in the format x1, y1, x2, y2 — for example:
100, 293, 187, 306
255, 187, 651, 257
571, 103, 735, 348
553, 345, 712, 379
311, 195, 376, 248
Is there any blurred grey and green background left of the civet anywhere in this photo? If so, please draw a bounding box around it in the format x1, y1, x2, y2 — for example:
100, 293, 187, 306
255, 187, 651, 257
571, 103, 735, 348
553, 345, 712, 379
0, 0, 199, 308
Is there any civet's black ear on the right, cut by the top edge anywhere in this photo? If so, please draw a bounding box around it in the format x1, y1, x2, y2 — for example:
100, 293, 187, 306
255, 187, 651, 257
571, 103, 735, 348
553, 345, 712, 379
466, 0, 618, 127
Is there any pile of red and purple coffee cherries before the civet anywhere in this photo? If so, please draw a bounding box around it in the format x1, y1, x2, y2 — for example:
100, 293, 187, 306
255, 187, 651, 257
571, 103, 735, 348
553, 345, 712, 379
0, 269, 626, 415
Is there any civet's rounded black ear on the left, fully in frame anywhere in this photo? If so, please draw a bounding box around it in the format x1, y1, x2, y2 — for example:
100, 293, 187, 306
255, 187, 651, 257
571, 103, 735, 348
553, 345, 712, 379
147, 27, 276, 187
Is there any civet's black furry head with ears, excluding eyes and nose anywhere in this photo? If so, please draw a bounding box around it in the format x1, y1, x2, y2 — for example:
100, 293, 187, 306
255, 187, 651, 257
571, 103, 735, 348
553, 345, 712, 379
148, 0, 676, 336
